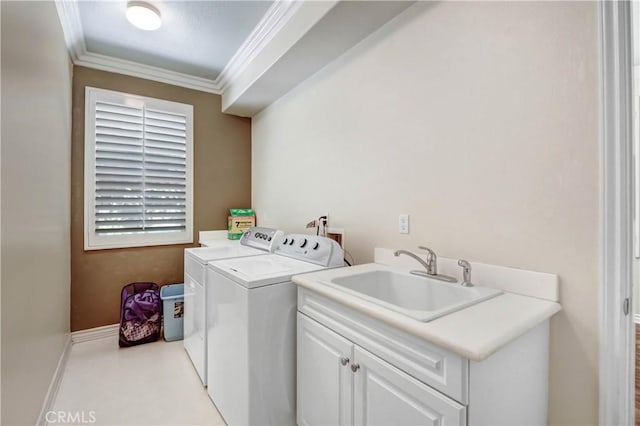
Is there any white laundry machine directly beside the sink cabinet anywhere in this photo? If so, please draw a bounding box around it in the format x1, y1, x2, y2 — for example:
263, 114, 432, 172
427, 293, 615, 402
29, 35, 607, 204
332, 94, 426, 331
207, 234, 344, 425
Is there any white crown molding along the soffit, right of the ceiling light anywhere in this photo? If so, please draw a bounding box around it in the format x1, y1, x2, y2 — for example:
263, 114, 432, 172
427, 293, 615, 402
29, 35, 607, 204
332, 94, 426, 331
216, 0, 302, 92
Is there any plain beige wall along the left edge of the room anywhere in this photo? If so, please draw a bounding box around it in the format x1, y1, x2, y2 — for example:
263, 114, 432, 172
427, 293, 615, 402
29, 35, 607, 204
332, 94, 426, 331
0, 1, 72, 425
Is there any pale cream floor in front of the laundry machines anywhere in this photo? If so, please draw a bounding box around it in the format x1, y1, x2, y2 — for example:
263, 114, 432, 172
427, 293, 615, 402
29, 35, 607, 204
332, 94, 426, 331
50, 336, 224, 425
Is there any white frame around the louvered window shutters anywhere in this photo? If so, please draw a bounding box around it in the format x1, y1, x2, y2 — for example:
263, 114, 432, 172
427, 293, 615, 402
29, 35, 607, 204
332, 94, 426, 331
84, 87, 193, 250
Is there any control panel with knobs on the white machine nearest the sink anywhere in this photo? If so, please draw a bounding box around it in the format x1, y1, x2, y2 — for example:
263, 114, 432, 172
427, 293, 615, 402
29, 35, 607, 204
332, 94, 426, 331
274, 234, 344, 267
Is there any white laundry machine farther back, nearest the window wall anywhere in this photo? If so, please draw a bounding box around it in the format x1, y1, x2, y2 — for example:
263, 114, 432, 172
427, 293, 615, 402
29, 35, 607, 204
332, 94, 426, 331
183, 227, 284, 386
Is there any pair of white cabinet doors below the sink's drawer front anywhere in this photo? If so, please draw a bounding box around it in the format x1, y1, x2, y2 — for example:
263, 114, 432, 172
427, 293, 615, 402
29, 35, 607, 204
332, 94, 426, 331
298, 313, 466, 425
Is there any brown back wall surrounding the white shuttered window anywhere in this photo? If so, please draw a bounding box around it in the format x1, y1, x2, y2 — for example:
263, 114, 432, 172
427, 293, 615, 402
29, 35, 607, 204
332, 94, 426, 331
71, 67, 251, 331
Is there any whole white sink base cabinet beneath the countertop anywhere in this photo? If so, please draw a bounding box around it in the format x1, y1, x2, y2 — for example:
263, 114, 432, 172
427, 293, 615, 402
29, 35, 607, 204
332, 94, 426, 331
297, 288, 549, 426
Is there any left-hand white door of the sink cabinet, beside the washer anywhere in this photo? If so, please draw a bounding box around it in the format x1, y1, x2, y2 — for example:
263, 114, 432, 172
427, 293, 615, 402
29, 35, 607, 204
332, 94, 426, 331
297, 313, 353, 425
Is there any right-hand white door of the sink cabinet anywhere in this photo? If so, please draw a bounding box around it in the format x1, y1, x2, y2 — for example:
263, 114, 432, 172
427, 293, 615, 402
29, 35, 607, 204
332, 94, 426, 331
353, 346, 467, 426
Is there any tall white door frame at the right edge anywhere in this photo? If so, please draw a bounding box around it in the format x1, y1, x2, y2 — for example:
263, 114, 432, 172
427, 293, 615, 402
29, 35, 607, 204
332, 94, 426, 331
598, 1, 635, 425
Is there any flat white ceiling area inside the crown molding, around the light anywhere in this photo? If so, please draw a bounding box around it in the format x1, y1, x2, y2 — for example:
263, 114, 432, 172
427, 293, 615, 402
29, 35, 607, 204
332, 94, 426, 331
77, 0, 273, 80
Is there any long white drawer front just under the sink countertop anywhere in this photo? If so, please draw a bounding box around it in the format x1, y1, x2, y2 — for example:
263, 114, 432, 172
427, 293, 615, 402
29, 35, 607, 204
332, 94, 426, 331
298, 288, 469, 404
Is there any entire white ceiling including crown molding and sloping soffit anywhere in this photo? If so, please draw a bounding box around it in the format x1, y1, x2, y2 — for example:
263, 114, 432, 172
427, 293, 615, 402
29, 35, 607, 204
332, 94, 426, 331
55, 0, 415, 117
